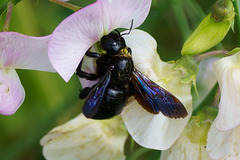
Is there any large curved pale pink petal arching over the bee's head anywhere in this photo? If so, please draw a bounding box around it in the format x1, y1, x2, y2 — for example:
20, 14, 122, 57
49, 0, 151, 81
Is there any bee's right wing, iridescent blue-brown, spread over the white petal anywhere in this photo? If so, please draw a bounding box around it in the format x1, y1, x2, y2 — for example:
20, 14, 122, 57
132, 68, 188, 119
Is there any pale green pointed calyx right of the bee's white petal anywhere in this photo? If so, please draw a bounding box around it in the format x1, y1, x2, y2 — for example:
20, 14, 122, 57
174, 56, 199, 95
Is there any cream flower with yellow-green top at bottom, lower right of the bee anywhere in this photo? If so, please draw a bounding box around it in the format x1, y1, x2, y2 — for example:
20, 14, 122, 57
160, 121, 211, 160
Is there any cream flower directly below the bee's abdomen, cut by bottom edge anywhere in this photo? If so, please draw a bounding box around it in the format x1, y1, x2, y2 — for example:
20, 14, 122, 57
40, 114, 128, 160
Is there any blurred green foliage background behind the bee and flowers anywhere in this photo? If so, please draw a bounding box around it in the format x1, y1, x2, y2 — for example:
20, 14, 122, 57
0, 0, 239, 160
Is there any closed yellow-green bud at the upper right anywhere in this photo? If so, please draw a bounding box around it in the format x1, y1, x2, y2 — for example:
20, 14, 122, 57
181, 0, 235, 55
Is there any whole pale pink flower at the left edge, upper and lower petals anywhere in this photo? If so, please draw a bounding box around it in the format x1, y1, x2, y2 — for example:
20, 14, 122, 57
0, 32, 54, 115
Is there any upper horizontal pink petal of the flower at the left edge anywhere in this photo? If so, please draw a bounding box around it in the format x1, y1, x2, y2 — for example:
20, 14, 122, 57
0, 32, 55, 72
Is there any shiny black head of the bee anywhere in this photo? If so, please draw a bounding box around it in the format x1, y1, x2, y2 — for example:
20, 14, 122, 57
100, 32, 126, 54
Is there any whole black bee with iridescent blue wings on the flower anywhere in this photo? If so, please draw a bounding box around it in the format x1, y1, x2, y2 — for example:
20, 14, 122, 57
76, 28, 188, 119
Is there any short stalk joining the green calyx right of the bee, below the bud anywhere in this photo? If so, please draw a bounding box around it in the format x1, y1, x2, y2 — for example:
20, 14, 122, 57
194, 50, 229, 63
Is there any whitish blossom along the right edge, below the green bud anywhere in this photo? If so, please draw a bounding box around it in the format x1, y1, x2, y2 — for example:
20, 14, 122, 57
207, 52, 240, 160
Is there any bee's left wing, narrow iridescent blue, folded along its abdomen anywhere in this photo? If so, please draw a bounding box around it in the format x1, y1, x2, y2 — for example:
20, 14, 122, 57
83, 69, 112, 118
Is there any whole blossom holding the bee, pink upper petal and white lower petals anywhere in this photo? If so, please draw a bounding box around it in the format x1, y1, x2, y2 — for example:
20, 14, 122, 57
49, 0, 192, 150
